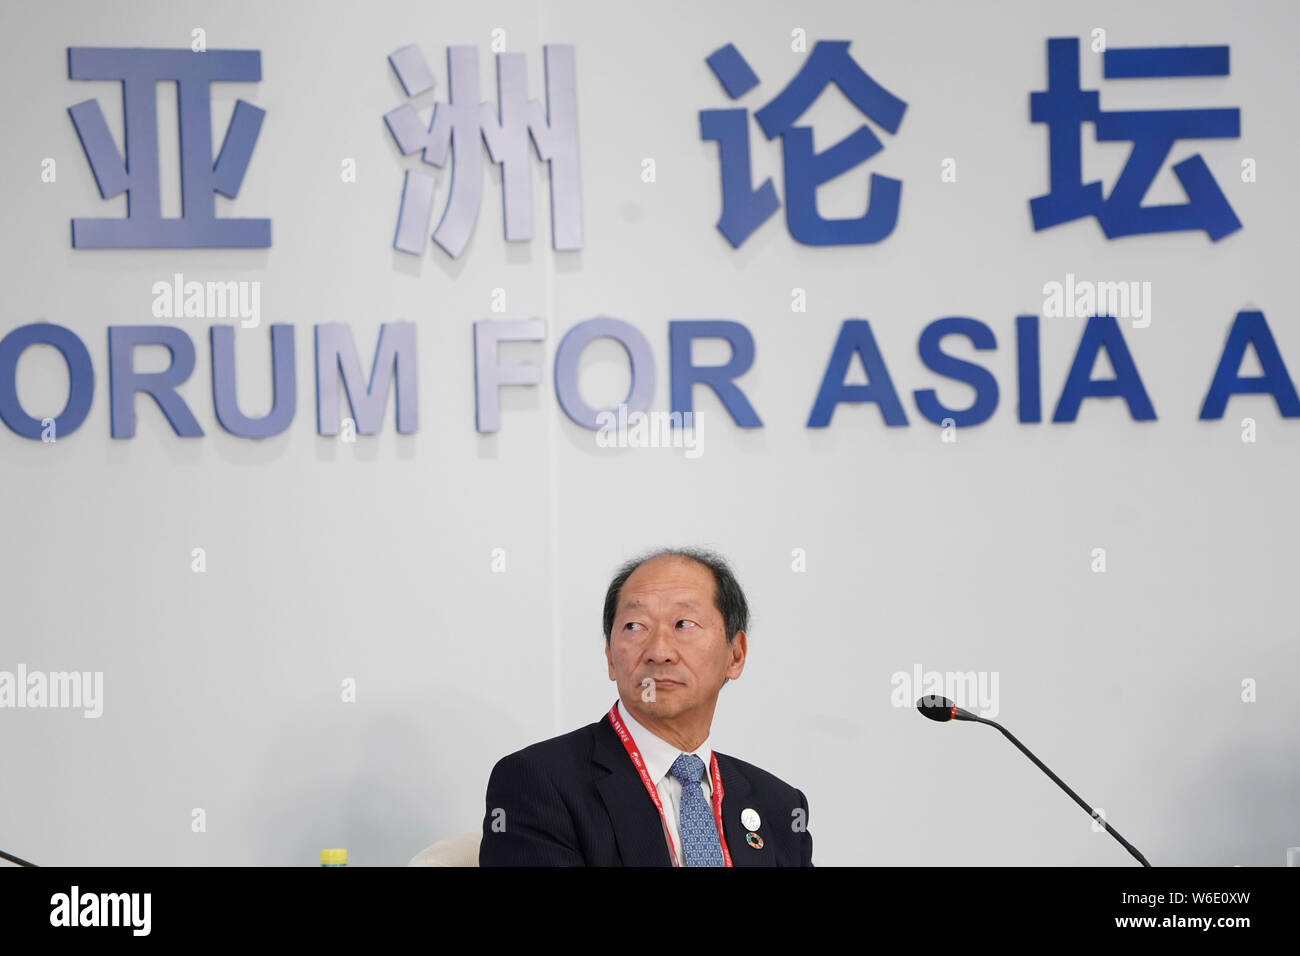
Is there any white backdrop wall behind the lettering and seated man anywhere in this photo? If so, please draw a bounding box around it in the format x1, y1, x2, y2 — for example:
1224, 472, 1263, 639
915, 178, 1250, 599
0, 3, 1300, 865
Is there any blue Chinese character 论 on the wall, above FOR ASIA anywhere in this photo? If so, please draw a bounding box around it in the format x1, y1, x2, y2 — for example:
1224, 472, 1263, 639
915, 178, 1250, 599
699, 40, 907, 248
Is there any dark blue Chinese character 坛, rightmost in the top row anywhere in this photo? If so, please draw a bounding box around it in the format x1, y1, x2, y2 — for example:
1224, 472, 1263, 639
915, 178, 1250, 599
1030, 38, 1242, 242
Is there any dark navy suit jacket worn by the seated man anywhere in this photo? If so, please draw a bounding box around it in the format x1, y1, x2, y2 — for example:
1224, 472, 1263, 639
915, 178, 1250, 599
478, 717, 813, 866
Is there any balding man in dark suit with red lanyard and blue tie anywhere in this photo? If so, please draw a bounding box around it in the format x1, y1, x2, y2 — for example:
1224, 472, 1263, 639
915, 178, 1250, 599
478, 549, 813, 866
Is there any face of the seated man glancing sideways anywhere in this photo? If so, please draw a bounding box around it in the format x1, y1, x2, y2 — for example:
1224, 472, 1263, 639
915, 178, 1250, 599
605, 555, 746, 719
